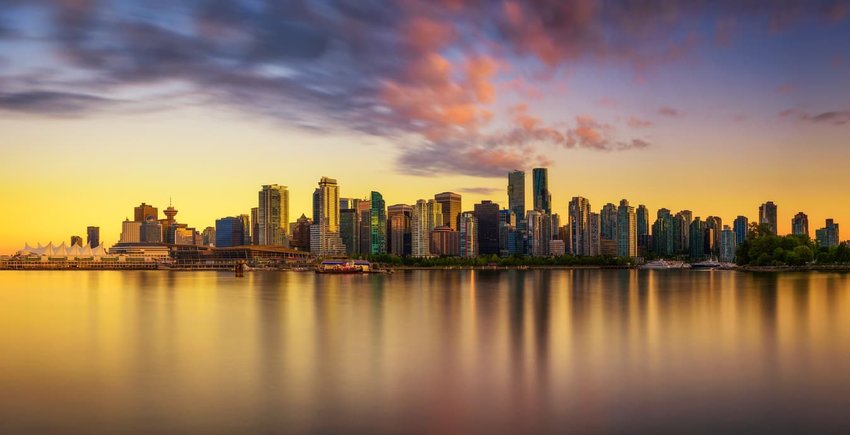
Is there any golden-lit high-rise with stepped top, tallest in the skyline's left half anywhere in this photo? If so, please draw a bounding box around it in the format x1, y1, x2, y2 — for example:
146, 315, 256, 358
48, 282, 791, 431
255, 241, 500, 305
308, 177, 344, 256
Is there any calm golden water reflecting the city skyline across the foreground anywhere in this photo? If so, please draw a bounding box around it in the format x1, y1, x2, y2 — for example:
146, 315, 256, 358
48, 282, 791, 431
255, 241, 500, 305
0, 270, 850, 433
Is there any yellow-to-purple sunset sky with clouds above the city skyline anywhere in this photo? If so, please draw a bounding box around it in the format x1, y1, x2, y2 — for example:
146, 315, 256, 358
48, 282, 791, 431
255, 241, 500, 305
0, 0, 850, 254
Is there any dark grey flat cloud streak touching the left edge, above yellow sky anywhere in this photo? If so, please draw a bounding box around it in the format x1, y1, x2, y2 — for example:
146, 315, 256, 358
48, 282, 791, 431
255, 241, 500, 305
0, 91, 116, 116
